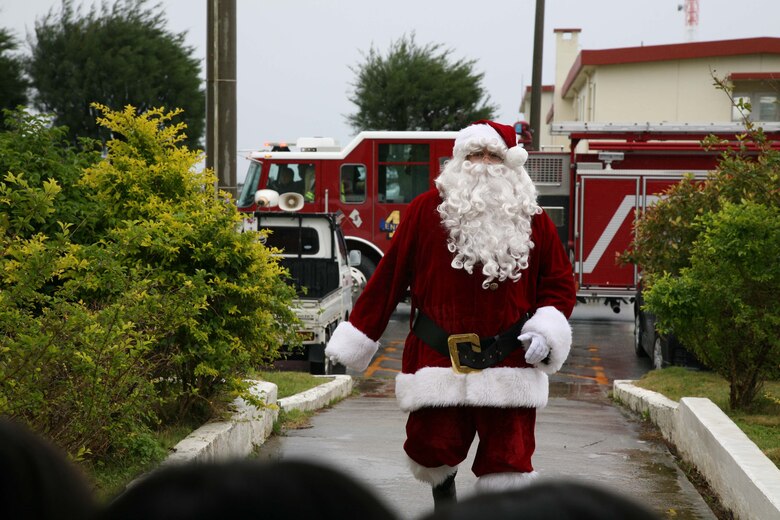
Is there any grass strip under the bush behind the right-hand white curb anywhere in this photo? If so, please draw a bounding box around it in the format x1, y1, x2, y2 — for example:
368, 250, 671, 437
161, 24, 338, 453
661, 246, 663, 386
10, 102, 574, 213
634, 367, 780, 467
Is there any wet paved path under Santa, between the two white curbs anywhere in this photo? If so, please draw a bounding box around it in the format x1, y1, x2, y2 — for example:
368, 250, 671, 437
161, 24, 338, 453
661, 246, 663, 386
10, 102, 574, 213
259, 303, 715, 519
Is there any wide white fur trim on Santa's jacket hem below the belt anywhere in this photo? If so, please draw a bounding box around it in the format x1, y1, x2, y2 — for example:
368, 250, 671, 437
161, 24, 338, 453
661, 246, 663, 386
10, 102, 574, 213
395, 367, 549, 412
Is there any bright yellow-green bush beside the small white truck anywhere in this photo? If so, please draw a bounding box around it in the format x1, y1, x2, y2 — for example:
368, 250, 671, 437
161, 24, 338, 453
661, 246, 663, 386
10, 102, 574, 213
84, 105, 297, 414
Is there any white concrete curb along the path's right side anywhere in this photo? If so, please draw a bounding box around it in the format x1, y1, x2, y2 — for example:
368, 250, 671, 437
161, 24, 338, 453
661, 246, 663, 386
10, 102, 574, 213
613, 380, 780, 519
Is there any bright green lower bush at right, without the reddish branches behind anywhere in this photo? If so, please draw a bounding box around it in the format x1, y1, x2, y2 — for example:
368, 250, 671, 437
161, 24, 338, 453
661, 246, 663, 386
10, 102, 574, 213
645, 201, 780, 410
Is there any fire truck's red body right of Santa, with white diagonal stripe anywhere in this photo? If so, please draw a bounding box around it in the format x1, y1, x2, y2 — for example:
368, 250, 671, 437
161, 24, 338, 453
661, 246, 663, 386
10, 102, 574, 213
551, 123, 780, 368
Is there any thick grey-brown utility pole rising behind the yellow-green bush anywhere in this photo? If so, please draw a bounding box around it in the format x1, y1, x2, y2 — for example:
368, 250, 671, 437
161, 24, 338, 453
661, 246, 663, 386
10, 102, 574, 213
206, 0, 238, 200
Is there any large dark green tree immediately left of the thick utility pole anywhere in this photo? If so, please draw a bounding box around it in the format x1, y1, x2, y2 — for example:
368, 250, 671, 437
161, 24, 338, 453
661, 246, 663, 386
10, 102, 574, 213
27, 0, 206, 148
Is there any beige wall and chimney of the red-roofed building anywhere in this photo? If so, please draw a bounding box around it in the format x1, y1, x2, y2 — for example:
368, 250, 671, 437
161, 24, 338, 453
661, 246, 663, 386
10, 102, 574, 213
536, 34, 780, 149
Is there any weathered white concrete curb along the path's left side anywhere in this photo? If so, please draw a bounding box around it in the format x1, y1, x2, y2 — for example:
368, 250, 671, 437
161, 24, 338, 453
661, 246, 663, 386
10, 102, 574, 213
162, 375, 353, 466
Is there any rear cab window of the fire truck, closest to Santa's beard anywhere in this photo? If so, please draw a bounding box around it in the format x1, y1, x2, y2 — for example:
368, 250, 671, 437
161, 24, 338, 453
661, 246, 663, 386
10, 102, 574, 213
377, 143, 430, 203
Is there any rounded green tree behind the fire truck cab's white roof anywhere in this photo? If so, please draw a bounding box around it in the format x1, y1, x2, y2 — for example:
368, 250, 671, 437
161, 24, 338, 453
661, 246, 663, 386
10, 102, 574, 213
347, 34, 497, 132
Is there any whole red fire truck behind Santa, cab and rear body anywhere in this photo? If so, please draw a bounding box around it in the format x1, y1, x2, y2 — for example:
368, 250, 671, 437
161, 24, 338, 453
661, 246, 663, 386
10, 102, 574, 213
237, 122, 780, 366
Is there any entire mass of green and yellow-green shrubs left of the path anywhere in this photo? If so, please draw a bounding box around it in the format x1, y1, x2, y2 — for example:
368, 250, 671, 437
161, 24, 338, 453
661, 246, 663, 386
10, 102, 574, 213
0, 106, 297, 458
